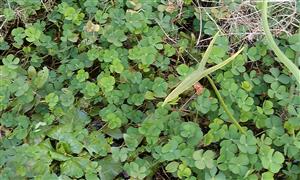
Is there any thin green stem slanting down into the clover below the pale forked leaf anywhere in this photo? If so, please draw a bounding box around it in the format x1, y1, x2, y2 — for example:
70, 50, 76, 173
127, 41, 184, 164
206, 76, 246, 134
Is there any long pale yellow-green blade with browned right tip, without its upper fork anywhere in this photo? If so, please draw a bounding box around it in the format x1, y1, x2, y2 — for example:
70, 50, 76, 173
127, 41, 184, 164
163, 48, 244, 106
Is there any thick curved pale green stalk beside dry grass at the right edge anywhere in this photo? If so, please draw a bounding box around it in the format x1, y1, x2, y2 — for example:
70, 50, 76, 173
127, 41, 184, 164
262, 0, 300, 84
